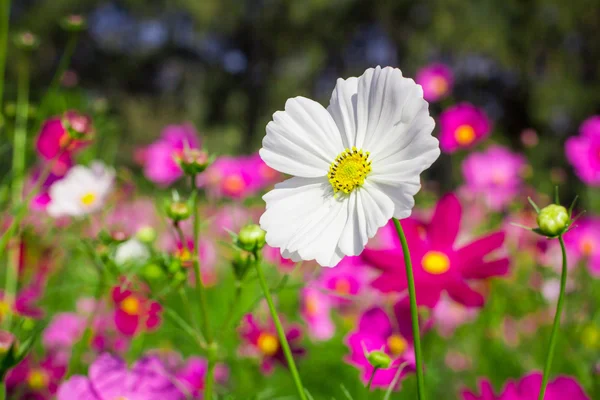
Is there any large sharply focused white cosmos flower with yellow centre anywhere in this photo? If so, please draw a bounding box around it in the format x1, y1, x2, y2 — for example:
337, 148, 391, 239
260, 67, 440, 266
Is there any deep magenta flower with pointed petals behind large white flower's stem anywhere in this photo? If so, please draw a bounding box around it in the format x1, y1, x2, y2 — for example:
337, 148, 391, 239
363, 194, 509, 308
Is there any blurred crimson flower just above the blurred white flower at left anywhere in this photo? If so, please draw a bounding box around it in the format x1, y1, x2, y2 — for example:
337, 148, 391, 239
36, 110, 94, 161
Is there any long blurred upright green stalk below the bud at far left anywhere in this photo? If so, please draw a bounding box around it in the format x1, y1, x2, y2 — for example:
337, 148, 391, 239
4, 52, 29, 327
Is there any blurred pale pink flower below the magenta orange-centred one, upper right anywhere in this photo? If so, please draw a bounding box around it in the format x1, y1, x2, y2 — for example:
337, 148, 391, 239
462, 146, 526, 210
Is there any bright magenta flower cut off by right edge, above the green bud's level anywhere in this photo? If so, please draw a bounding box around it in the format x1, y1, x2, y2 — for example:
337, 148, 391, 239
565, 115, 600, 186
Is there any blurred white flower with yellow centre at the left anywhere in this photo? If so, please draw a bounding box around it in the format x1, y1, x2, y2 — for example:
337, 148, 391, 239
47, 161, 115, 218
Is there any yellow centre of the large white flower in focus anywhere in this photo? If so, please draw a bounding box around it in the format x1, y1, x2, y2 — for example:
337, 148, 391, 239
327, 147, 371, 194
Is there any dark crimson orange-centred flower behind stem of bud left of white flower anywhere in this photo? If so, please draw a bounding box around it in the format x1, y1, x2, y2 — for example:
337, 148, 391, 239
239, 314, 305, 374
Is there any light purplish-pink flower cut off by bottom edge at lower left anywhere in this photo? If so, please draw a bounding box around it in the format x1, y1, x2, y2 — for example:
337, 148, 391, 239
57, 353, 184, 400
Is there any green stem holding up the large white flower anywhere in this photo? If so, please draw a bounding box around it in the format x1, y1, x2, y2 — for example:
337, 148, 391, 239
394, 218, 425, 400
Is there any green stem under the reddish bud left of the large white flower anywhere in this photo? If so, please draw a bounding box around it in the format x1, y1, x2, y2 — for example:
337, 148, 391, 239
191, 176, 216, 400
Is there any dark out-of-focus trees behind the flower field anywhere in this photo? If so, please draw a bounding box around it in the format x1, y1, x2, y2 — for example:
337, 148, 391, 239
4, 0, 600, 200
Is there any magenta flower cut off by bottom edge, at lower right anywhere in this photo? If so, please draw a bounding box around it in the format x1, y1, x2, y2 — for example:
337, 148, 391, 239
462, 372, 590, 400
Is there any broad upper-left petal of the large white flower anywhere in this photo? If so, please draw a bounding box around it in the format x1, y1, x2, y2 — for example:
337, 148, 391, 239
260, 97, 344, 178
